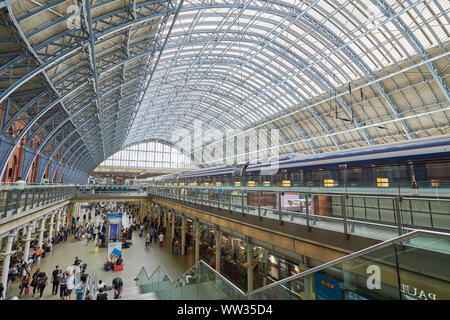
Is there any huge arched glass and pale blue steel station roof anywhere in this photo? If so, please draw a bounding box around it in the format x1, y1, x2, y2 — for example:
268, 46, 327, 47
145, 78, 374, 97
0, 0, 450, 181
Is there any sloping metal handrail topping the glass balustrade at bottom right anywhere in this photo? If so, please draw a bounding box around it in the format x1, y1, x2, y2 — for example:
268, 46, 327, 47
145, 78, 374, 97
245, 230, 450, 296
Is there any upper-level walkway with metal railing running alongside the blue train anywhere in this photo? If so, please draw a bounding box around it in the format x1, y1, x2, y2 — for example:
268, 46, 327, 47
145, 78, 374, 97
148, 185, 450, 241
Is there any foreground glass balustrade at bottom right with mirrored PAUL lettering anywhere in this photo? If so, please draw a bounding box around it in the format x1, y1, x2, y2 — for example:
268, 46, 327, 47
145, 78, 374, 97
236, 231, 450, 300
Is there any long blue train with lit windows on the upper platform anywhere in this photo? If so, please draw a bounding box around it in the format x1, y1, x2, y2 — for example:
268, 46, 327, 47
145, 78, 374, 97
150, 135, 450, 187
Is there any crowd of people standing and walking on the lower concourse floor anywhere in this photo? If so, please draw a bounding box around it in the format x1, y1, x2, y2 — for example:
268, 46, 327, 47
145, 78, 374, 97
0, 202, 172, 300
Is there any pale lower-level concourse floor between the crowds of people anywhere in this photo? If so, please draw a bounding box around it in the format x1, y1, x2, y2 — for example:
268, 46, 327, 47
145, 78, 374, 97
6, 212, 195, 300
